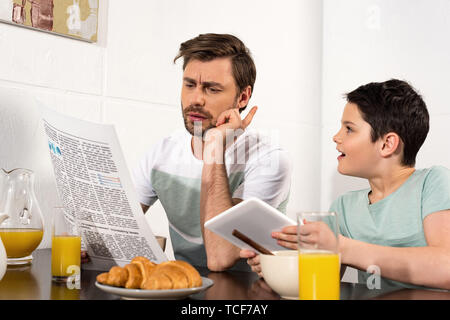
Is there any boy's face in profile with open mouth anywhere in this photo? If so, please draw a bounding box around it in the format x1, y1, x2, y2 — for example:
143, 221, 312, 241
333, 103, 379, 179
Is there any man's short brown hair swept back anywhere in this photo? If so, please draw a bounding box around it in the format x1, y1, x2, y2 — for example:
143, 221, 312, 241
173, 33, 256, 111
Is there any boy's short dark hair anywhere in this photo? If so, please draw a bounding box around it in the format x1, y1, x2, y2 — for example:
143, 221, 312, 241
346, 79, 430, 167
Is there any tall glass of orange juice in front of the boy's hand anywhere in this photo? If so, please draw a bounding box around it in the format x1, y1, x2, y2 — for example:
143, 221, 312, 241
297, 212, 340, 300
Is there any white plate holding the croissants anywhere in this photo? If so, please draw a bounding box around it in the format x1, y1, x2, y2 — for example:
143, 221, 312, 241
95, 277, 214, 299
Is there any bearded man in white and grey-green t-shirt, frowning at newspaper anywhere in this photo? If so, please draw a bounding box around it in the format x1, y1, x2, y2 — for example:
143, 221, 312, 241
134, 34, 290, 271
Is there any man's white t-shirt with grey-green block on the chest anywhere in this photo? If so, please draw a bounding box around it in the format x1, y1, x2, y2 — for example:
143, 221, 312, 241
133, 130, 291, 270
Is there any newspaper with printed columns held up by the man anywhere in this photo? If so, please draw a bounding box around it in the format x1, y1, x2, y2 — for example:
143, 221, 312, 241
42, 108, 167, 270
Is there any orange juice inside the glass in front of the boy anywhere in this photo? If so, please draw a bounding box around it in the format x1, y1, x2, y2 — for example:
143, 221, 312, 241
298, 252, 340, 300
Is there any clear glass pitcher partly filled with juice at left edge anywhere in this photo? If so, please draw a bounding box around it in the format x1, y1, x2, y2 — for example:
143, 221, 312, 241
0, 168, 44, 265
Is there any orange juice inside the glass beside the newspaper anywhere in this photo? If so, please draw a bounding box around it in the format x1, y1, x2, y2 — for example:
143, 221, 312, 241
52, 236, 81, 277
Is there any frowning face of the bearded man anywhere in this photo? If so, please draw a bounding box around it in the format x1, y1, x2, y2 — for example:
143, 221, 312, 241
181, 58, 239, 135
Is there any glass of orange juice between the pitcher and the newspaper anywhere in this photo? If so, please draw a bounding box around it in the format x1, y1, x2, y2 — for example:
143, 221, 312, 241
52, 207, 81, 283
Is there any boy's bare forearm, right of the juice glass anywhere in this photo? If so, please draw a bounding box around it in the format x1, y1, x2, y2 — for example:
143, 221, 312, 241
340, 237, 450, 289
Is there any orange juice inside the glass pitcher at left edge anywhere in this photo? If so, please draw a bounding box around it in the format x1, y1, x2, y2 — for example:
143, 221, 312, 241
0, 228, 44, 258
